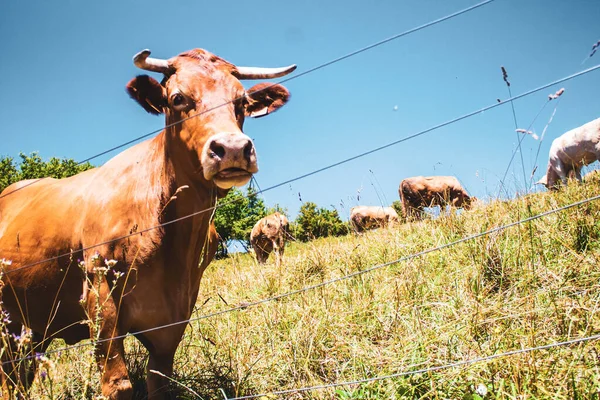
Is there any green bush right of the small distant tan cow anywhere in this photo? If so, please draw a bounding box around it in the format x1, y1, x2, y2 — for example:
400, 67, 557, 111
292, 202, 349, 242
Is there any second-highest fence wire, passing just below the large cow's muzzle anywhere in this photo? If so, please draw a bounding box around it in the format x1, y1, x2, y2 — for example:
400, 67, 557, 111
4, 64, 600, 274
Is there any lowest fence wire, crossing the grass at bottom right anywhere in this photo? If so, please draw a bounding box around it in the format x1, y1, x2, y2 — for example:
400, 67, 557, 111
226, 335, 600, 400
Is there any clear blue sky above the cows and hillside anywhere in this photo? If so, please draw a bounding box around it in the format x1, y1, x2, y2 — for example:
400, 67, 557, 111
0, 0, 600, 217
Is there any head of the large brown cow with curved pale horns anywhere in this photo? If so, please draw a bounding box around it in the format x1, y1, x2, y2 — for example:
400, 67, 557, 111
127, 49, 296, 189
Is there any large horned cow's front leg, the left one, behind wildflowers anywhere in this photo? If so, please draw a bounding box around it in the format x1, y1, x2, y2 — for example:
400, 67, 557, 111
86, 275, 133, 400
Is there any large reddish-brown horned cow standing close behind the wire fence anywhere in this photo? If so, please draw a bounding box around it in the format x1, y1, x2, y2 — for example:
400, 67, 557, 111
0, 49, 295, 399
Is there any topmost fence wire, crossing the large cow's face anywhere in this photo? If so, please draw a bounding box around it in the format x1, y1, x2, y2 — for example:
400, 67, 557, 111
0, 0, 495, 199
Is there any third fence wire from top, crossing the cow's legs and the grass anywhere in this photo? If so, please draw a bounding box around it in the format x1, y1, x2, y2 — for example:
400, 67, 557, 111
1, 189, 600, 365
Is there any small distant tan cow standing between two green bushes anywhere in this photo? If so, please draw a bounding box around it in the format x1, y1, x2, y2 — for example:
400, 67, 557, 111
250, 212, 290, 266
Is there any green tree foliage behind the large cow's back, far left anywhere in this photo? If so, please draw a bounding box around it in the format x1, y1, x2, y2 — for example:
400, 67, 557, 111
0, 152, 94, 192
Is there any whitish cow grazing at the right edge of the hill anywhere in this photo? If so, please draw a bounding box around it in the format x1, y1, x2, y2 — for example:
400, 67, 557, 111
537, 118, 600, 189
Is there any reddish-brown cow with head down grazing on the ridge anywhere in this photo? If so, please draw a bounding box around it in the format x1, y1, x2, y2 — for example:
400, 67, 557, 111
398, 176, 476, 219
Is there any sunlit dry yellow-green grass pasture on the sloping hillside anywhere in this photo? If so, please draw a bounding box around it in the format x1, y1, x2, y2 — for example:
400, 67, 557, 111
29, 178, 600, 400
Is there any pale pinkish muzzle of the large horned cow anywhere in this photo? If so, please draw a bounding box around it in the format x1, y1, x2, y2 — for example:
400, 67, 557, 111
201, 132, 258, 189
